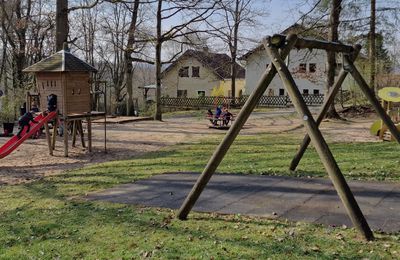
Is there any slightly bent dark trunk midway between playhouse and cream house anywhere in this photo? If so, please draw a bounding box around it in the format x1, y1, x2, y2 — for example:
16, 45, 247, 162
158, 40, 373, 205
124, 0, 140, 116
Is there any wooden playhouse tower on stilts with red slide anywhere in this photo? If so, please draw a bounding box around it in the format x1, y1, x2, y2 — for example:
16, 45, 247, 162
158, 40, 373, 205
0, 44, 106, 158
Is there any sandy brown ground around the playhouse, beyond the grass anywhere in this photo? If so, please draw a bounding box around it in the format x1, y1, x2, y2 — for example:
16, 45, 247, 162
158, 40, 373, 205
0, 109, 377, 185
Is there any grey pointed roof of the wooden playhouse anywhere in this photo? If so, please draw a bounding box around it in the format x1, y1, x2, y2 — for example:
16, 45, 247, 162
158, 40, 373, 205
23, 50, 97, 72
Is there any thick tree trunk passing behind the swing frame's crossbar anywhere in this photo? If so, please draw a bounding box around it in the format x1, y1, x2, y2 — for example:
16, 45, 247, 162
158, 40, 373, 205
326, 0, 342, 118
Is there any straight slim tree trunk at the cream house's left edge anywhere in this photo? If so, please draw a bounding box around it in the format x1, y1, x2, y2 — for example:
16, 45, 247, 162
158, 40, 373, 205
154, 0, 163, 121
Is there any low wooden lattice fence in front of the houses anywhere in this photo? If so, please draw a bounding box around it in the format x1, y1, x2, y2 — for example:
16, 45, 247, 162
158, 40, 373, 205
161, 95, 324, 109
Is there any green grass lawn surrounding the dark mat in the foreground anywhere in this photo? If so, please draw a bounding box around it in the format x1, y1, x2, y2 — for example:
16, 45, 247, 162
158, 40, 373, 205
0, 134, 400, 259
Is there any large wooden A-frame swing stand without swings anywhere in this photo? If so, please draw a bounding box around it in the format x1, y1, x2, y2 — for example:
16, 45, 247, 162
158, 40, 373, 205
178, 34, 400, 240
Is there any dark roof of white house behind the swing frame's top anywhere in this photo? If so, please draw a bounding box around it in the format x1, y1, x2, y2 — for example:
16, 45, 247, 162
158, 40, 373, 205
239, 23, 327, 60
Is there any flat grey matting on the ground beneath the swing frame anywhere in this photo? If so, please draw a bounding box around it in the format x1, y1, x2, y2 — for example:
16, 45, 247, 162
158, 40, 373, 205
88, 173, 400, 232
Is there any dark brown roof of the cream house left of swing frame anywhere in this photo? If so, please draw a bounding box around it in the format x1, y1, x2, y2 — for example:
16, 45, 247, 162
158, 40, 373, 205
163, 50, 245, 79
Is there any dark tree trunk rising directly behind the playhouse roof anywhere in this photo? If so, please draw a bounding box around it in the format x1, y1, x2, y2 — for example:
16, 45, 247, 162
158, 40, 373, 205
56, 0, 69, 51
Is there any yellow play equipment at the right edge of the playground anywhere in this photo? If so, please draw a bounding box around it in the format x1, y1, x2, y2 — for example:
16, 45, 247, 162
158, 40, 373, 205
370, 87, 400, 141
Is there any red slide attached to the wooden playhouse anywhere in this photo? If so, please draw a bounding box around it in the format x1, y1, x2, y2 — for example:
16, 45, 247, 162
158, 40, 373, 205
0, 111, 57, 159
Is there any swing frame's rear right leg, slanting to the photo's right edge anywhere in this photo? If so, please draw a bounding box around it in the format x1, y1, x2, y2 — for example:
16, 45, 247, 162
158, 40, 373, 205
344, 55, 400, 143
